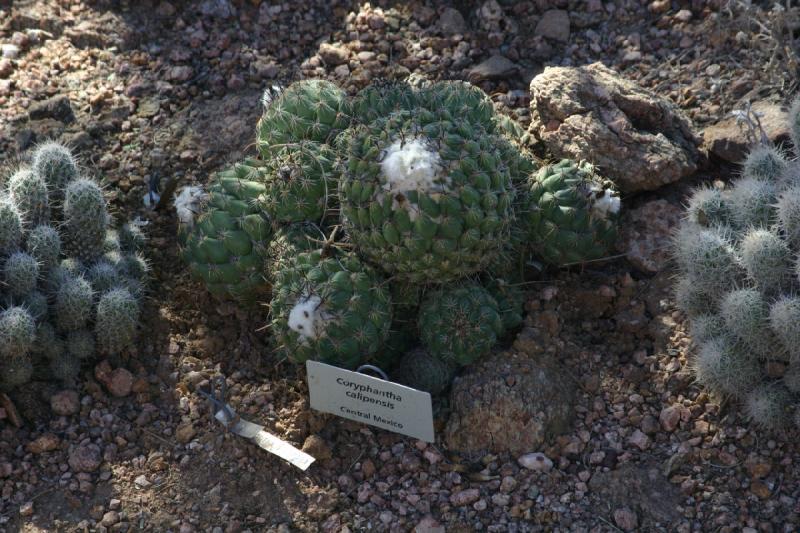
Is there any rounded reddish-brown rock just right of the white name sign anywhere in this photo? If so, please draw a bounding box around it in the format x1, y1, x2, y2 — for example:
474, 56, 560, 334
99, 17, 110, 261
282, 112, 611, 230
445, 353, 575, 455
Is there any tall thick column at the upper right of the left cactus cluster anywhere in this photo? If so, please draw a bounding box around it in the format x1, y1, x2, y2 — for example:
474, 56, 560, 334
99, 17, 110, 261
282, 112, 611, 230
63, 178, 109, 263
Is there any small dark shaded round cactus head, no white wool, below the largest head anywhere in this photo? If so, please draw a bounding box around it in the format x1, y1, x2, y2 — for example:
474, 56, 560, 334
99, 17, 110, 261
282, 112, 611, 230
418, 282, 503, 366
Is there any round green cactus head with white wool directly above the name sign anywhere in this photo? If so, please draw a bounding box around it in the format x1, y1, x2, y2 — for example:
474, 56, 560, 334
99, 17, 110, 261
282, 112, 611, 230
271, 250, 391, 368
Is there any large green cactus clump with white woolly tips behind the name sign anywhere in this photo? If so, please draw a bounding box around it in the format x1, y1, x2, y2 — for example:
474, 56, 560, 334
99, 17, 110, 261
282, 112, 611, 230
175, 80, 620, 392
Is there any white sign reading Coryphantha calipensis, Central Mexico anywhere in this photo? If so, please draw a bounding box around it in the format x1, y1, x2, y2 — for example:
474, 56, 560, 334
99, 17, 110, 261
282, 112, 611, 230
306, 361, 434, 442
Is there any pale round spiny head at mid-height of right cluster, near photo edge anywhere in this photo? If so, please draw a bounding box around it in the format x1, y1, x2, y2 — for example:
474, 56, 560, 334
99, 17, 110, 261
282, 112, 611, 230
739, 229, 794, 294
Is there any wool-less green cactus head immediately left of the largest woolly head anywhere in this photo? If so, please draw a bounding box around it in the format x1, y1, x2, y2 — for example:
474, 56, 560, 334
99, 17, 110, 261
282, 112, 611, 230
258, 142, 338, 223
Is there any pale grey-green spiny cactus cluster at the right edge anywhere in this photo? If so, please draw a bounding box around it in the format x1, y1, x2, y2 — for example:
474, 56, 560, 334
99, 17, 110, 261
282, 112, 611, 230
675, 103, 800, 427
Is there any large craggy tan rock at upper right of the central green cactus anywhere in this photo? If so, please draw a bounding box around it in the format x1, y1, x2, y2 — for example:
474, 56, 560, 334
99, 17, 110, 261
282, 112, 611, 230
531, 63, 700, 193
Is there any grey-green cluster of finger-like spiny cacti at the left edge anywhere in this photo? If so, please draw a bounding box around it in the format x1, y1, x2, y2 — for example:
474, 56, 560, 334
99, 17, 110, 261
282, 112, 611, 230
0, 142, 147, 391
